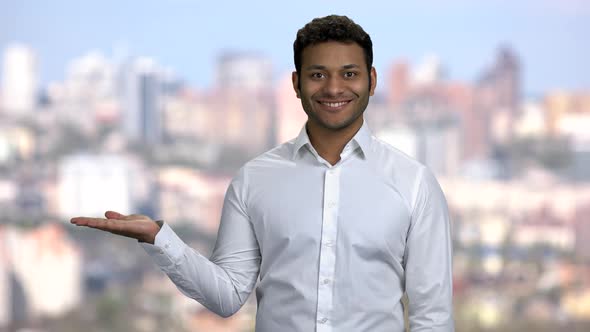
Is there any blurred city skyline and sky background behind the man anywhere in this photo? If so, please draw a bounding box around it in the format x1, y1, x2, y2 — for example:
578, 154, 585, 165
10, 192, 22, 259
0, 0, 590, 332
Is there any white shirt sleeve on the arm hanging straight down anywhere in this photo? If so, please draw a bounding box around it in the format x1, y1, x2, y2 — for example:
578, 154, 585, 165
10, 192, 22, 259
404, 167, 454, 332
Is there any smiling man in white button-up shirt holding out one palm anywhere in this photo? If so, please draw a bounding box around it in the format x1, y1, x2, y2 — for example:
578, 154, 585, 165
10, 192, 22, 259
72, 16, 454, 332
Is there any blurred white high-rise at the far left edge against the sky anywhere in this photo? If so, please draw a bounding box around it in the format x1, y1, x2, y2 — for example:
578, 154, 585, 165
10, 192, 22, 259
0, 44, 39, 114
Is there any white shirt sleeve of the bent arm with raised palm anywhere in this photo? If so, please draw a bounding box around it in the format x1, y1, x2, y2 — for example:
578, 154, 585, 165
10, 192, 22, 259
141, 170, 260, 317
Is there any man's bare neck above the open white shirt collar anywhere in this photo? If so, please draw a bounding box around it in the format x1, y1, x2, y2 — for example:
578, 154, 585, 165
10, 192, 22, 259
306, 118, 364, 165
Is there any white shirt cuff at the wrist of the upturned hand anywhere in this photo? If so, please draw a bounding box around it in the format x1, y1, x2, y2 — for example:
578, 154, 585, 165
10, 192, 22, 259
140, 223, 186, 267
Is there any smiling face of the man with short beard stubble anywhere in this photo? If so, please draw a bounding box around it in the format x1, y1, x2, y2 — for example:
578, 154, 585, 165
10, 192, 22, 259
293, 41, 377, 131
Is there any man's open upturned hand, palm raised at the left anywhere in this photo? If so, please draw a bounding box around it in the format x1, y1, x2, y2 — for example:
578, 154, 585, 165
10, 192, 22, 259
70, 211, 160, 244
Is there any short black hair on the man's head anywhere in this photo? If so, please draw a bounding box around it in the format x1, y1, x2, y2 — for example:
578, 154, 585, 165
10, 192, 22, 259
293, 15, 373, 74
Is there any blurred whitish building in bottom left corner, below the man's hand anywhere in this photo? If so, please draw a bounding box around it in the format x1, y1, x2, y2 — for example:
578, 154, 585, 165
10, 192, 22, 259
0, 223, 82, 326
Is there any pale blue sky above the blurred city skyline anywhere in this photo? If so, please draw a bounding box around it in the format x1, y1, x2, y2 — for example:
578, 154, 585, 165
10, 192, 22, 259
0, 0, 590, 95
